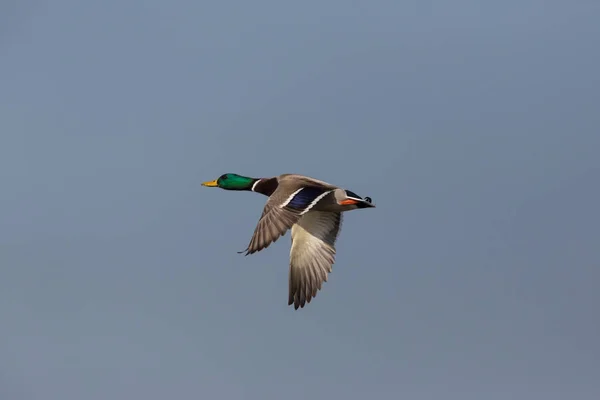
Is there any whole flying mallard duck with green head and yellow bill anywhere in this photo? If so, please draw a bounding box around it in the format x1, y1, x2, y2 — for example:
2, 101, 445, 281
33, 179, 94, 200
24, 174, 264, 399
203, 174, 375, 309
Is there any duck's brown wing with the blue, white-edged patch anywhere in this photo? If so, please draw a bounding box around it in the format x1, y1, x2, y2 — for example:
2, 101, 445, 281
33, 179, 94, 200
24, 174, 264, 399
241, 185, 331, 255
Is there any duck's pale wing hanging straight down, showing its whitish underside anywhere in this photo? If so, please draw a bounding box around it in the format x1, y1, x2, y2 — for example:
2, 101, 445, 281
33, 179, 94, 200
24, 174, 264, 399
288, 211, 342, 310
